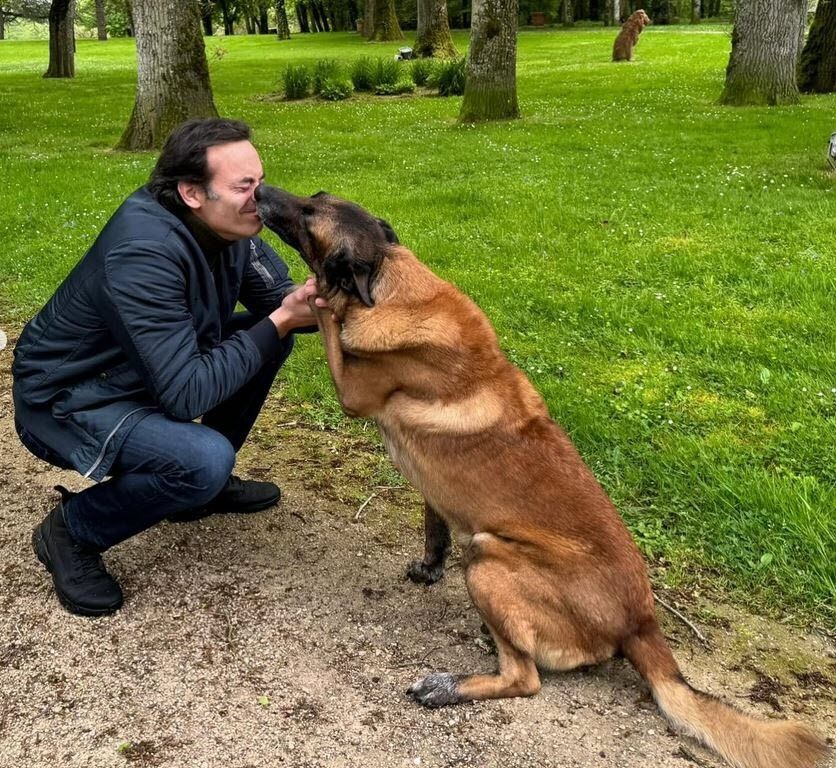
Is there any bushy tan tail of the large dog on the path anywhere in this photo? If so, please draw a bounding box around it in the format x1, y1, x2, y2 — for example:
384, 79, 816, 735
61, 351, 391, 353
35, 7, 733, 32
622, 620, 828, 768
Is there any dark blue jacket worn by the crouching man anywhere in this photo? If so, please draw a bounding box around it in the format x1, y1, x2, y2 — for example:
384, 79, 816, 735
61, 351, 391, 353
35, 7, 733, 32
12, 188, 295, 480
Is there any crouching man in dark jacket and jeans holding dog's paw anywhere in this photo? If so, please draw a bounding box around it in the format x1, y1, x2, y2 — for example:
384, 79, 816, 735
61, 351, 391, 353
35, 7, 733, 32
13, 118, 315, 616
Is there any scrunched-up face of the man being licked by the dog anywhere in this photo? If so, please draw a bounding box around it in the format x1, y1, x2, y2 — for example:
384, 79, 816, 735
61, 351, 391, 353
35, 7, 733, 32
185, 141, 264, 240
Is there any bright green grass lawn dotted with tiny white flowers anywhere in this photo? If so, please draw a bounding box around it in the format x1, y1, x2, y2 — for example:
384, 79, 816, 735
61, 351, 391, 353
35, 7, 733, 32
0, 30, 836, 628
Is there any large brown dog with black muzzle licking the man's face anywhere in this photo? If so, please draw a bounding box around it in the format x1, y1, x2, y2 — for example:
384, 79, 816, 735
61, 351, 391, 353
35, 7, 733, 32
256, 186, 826, 768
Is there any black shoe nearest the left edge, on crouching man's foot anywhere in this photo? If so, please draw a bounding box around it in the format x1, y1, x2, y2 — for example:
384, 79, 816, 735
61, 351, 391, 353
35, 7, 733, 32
32, 486, 122, 616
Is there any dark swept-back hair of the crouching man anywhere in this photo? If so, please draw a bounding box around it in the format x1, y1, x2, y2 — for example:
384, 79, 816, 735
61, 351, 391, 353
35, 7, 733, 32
148, 117, 250, 213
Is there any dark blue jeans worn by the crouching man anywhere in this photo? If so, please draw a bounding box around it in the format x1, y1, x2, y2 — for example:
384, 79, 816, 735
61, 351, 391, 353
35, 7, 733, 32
64, 313, 293, 551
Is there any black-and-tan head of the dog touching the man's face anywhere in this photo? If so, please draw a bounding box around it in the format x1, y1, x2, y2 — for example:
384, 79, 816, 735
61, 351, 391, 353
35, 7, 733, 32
255, 184, 398, 307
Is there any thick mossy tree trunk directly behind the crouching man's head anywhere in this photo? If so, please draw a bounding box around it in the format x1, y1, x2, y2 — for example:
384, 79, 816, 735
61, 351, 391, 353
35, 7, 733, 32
117, 0, 218, 150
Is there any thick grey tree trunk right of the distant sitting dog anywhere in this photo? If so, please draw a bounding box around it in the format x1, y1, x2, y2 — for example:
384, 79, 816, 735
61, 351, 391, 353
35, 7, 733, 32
720, 0, 807, 106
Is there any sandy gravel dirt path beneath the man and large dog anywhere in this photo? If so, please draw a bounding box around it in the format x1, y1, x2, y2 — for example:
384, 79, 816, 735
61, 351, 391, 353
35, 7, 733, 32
0, 349, 836, 768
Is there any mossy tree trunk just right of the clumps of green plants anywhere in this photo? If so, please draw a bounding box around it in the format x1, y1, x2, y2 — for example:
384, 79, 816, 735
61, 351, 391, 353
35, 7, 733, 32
459, 0, 520, 122
